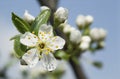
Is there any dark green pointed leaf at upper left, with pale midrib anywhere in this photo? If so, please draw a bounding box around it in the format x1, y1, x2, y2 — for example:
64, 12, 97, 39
12, 12, 31, 33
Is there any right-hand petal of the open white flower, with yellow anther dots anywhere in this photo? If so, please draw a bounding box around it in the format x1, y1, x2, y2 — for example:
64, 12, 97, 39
47, 36, 65, 50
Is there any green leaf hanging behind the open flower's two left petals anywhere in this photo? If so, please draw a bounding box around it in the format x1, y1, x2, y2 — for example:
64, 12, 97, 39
14, 37, 26, 58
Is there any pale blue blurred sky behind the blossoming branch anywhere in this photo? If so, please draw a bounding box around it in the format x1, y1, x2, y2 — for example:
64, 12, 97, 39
0, 0, 120, 79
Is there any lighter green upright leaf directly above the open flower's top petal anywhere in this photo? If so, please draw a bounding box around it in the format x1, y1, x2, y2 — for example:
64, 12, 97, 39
32, 9, 50, 35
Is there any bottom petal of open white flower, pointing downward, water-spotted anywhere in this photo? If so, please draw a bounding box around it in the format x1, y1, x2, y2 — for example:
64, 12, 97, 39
41, 53, 57, 71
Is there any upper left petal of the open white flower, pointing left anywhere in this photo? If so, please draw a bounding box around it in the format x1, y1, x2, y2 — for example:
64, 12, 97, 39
20, 32, 38, 46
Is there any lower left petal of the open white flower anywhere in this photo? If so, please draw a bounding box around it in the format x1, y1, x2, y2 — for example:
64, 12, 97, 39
22, 48, 39, 68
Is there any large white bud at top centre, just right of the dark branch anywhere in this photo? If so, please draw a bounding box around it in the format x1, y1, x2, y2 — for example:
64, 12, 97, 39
55, 7, 68, 22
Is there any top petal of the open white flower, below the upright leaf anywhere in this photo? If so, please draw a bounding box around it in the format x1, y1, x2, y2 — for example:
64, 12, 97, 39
38, 24, 53, 40
